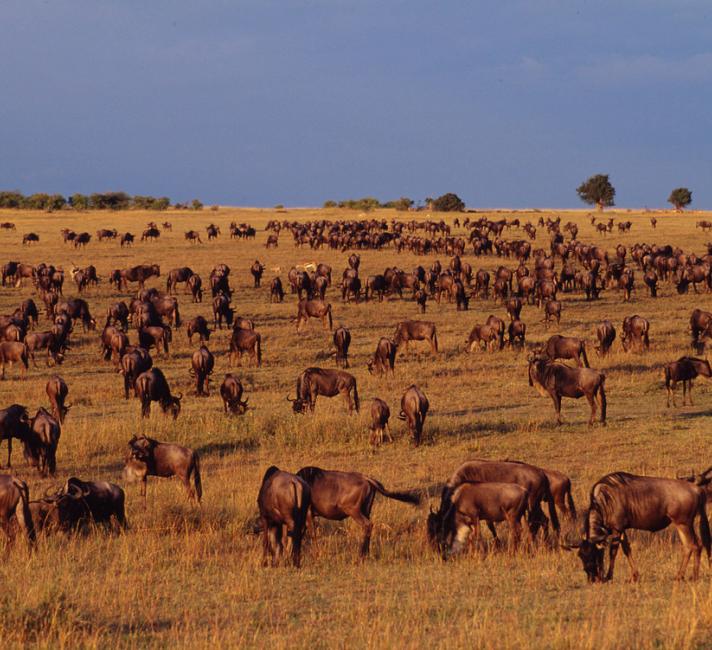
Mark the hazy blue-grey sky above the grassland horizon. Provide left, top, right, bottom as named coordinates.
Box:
left=0, top=0, right=712, bottom=208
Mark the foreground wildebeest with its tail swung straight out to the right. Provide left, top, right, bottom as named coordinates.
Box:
left=297, top=467, right=420, bottom=557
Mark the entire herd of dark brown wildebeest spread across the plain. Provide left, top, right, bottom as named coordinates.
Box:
left=0, top=215, right=712, bottom=582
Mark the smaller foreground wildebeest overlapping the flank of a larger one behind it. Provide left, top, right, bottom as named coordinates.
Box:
left=427, top=481, right=534, bottom=559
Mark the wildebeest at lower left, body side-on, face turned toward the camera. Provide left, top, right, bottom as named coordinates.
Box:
left=124, top=436, right=203, bottom=507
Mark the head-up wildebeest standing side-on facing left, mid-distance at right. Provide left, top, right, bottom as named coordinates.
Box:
left=529, top=355, right=606, bottom=426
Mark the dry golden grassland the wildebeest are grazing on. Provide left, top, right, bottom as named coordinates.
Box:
left=0, top=208, right=712, bottom=648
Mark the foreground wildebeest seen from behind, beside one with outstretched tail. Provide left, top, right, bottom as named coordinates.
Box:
left=257, top=465, right=311, bottom=568
